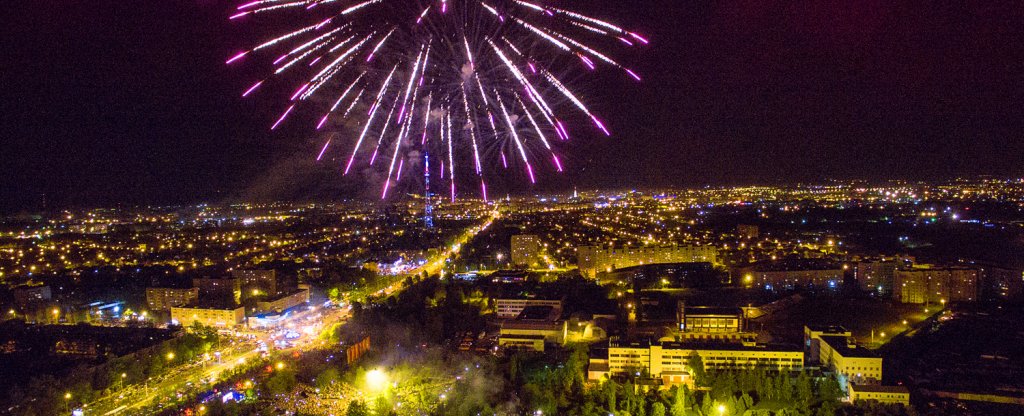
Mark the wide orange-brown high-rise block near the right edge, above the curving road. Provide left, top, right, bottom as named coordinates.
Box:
left=893, top=267, right=979, bottom=303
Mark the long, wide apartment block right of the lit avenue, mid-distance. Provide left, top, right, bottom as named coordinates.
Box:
left=577, top=246, right=718, bottom=278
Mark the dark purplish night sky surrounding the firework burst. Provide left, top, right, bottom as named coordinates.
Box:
left=0, top=0, right=1024, bottom=211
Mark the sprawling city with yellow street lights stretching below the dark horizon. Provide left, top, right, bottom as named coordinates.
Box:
left=0, top=179, right=1024, bottom=416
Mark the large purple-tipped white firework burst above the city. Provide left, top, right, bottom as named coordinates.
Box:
left=226, top=0, right=647, bottom=200
